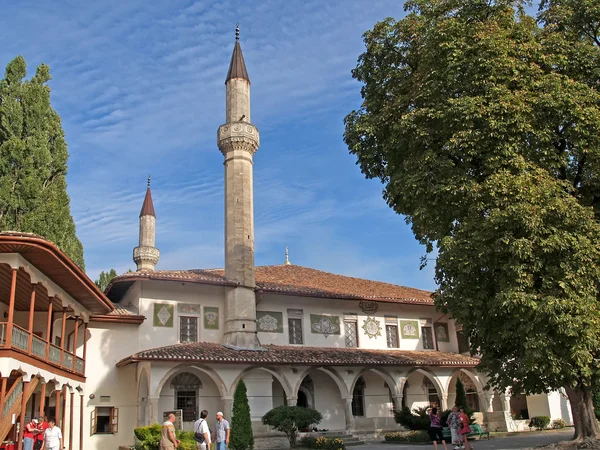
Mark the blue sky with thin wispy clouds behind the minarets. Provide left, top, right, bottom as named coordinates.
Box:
left=0, top=0, right=435, bottom=289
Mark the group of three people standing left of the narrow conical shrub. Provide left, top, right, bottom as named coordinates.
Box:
left=160, top=410, right=231, bottom=450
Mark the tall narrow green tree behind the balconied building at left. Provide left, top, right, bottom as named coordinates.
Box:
left=0, top=56, right=84, bottom=269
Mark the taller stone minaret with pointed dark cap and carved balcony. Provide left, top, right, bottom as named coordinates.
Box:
left=217, top=26, right=260, bottom=349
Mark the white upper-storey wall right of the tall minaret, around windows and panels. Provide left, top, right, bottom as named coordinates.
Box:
left=257, top=293, right=458, bottom=352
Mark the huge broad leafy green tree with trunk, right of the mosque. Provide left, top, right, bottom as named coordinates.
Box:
left=345, top=0, right=600, bottom=438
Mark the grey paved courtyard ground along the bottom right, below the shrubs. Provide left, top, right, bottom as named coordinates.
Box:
left=359, top=429, right=573, bottom=450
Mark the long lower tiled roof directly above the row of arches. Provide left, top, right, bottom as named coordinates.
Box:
left=117, top=342, right=479, bottom=367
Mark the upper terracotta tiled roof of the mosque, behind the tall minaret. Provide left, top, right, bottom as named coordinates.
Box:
left=108, top=264, right=433, bottom=305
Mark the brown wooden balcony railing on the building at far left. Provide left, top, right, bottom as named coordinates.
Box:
left=0, top=322, right=85, bottom=375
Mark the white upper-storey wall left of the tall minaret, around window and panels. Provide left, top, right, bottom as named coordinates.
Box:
left=138, top=280, right=225, bottom=351
